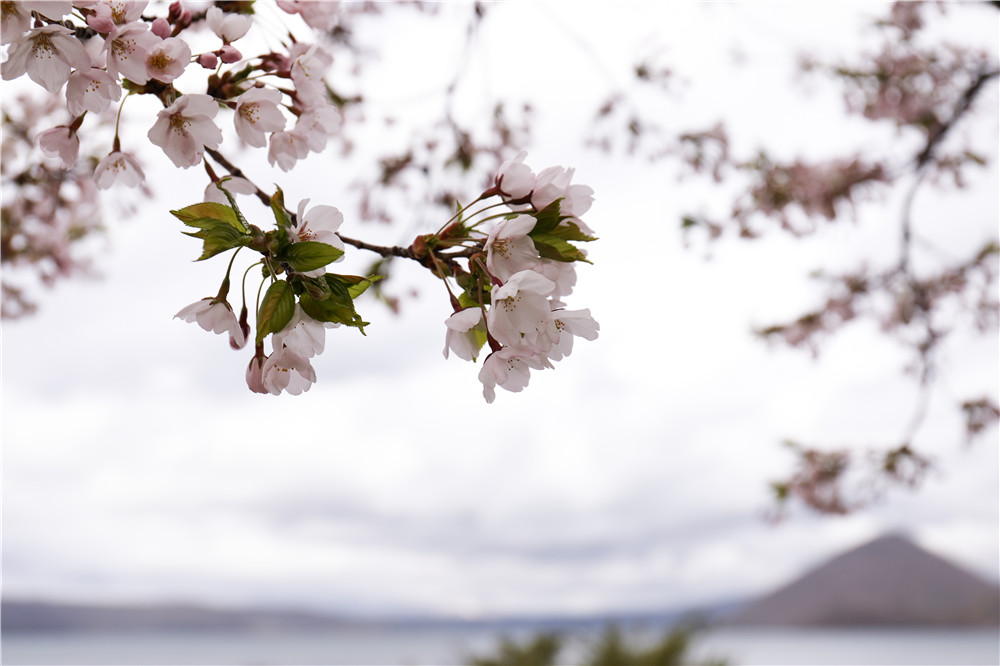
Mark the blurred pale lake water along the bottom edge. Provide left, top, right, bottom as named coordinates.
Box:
left=0, top=627, right=1000, bottom=666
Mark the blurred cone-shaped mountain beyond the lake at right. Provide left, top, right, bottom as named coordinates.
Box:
left=729, top=535, right=1000, bottom=627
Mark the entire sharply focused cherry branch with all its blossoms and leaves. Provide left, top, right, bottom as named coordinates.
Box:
left=2, top=0, right=598, bottom=402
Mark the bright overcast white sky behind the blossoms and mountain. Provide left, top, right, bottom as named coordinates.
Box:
left=2, top=3, right=1000, bottom=616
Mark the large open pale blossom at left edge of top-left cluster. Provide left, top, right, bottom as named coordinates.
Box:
left=3, top=25, right=90, bottom=92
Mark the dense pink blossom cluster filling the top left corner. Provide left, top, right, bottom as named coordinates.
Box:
left=2, top=0, right=340, bottom=189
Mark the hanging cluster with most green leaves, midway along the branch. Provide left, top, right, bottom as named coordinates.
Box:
left=172, top=183, right=360, bottom=395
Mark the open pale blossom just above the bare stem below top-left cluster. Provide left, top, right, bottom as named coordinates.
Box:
left=148, top=94, right=222, bottom=168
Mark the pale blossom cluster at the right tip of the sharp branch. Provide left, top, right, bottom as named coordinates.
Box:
left=436, top=151, right=600, bottom=402
